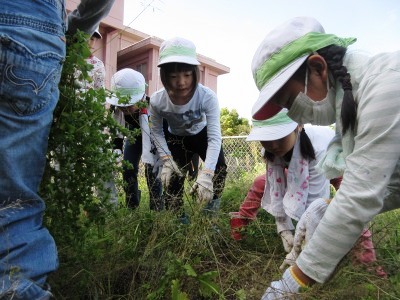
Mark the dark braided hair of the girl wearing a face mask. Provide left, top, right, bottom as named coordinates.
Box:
left=317, top=45, right=357, bottom=135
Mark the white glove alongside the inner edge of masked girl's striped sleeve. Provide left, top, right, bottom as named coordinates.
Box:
left=279, top=198, right=330, bottom=270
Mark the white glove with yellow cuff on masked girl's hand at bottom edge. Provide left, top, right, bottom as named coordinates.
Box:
left=261, top=267, right=306, bottom=300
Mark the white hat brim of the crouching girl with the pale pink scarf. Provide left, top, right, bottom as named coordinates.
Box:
left=246, top=122, right=297, bottom=142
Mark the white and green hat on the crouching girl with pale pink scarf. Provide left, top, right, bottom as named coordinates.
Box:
left=246, top=109, right=298, bottom=141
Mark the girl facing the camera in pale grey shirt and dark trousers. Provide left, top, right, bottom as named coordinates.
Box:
left=150, top=37, right=226, bottom=222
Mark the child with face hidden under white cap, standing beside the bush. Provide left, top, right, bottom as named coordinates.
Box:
left=107, top=68, right=163, bottom=210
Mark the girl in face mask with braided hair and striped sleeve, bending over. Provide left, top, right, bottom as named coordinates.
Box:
left=252, top=17, right=400, bottom=299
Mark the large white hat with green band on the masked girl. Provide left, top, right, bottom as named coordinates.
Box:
left=251, top=17, right=356, bottom=120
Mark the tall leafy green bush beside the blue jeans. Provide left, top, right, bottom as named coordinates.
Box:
left=40, top=32, right=135, bottom=246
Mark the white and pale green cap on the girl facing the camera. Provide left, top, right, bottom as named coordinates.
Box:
left=157, top=37, right=200, bottom=67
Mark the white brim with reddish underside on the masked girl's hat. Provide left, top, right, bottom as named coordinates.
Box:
left=251, top=54, right=309, bottom=120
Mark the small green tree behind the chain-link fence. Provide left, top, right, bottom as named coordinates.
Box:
left=220, top=108, right=250, bottom=136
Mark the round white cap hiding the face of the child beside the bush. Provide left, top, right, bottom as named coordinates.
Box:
left=106, top=68, right=146, bottom=107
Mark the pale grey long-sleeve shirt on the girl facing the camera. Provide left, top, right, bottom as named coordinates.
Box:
left=150, top=84, right=222, bottom=171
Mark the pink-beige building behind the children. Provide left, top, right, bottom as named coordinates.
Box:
left=66, top=0, right=230, bottom=95
